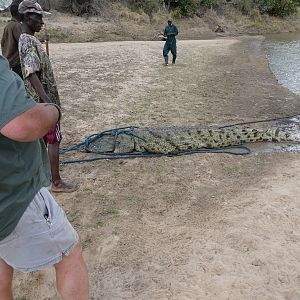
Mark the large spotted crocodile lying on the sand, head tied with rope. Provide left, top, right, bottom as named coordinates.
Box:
left=85, top=126, right=299, bottom=154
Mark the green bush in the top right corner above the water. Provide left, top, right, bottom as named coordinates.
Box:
left=254, top=0, right=298, bottom=17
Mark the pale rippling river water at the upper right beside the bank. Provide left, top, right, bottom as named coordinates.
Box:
left=264, top=33, right=300, bottom=95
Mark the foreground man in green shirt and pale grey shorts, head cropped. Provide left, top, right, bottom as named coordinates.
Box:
left=0, top=56, right=88, bottom=300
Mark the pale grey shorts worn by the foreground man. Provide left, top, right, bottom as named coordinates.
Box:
left=0, top=188, right=79, bottom=272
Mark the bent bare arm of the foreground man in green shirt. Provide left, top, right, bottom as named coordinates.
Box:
left=0, top=103, right=60, bottom=142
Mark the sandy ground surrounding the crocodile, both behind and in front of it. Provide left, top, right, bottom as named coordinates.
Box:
left=9, top=37, right=300, bottom=300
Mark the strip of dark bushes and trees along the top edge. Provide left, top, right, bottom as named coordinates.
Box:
left=39, top=0, right=300, bottom=18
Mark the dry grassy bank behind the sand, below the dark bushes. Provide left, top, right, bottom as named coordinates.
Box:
left=0, top=1, right=300, bottom=43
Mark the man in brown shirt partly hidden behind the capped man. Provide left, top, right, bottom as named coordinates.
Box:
left=1, top=0, right=22, bottom=77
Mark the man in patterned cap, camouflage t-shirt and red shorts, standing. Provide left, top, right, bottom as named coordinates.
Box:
left=19, top=0, right=78, bottom=192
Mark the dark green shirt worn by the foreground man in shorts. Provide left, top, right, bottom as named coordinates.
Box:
left=0, top=56, right=50, bottom=240
